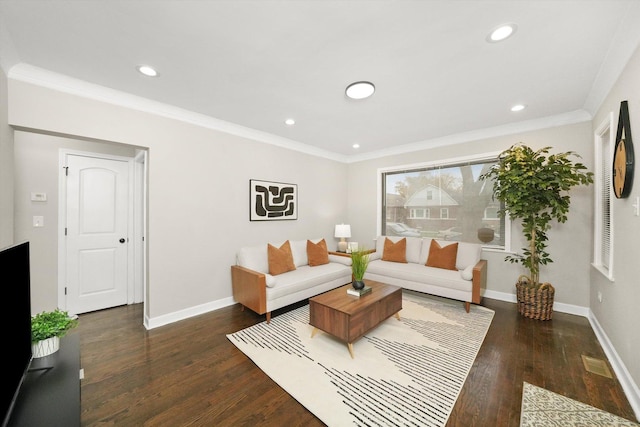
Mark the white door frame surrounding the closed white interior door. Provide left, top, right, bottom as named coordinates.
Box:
left=58, top=148, right=147, bottom=310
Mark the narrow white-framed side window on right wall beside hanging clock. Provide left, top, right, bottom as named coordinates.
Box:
left=591, top=112, right=615, bottom=282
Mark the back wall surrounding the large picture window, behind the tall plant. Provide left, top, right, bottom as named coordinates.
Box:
left=349, top=122, right=593, bottom=308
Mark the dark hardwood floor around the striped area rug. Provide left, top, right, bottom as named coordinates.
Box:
left=77, top=298, right=636, bottom=427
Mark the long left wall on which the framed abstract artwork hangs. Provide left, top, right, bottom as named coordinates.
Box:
left=9, top=79, right=347, bottom=325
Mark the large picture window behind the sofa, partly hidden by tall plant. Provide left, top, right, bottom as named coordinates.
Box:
left=380, top=155, right=506, bottom=248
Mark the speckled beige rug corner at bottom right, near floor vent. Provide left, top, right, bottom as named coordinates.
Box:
left=520, top=382, right=640, bottom=427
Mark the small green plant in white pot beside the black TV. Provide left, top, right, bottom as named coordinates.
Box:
left=31, top=308, right=78, bottom=358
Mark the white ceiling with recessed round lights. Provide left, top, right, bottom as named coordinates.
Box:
left=0, top=0, right=640, bottom=159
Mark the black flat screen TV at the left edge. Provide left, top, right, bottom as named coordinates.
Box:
left=0, top=242, right=32, bottom=427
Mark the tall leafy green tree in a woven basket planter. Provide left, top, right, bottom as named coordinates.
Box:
left=480, top=143, right=593, bottom=320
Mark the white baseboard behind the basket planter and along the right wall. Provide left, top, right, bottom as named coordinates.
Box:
left=483, top=290, right=640, bottom=420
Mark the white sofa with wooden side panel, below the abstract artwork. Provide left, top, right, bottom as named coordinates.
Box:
left=231, top=239, right=351, bottom=323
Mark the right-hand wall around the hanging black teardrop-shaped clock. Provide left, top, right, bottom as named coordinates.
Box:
left=590, top=42, right=640, bottom=413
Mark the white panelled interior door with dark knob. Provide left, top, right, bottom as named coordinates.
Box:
left=65, top=154, right=130, bottom=314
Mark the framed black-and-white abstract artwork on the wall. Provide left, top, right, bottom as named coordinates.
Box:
left=249, top=179, right=298, bottom=221
